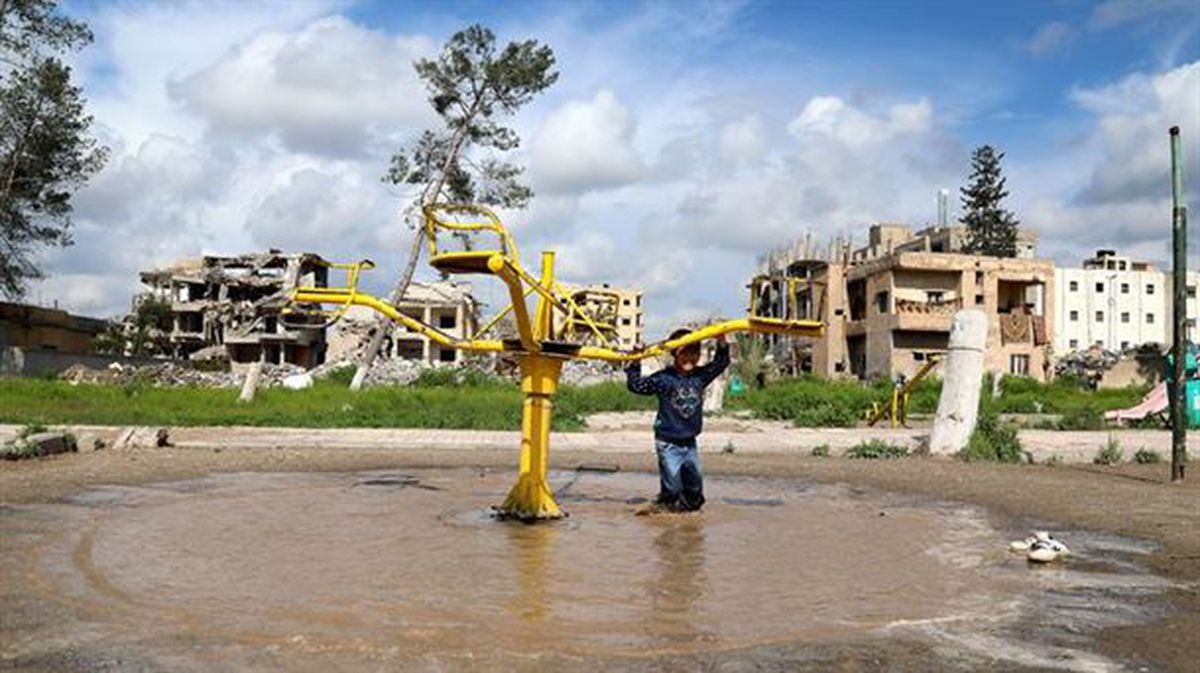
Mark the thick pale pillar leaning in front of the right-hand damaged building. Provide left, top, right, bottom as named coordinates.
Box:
left=929, top=310, right=988, bottom=456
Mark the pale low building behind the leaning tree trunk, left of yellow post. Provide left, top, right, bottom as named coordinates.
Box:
left=328, top=281, right=479, bottom=365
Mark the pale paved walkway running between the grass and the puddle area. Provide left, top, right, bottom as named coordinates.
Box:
left=0, top=423, right=1200, bottom=462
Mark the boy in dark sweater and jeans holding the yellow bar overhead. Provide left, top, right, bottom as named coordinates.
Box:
left=625, top=330, right=730, bottom=513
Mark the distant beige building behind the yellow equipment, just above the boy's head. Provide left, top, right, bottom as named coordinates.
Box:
left=554, top=283, right=644, bottom=349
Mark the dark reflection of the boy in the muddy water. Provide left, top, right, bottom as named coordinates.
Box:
left=647, top=516, right=708, bottom=643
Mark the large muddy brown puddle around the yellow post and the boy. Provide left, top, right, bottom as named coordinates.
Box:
left=0, top=469, right=1169, bottom=671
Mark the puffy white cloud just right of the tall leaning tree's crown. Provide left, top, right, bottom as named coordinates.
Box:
left=529, top=89, right=643, bottom=193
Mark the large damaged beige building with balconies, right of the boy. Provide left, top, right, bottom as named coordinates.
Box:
left=751, top=224, right=1055, bottom=380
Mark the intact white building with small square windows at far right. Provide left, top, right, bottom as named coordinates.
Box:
left=1055, top=250, right=1200, bottom=353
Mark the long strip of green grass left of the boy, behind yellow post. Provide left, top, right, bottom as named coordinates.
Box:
left=0, top=377, right=654, bottom=431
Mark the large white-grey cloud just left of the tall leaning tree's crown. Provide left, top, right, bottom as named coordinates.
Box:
left=172, top=17, right=433, bottom=157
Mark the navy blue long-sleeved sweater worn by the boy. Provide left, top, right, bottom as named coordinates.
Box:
left=625, top=344, right=730, bottom=446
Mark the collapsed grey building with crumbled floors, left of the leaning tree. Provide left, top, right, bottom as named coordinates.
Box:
left=140, top=250, right=329, bottom=369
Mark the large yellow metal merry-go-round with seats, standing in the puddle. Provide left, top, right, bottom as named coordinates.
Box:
left=283, top=204, right=823, bottom=521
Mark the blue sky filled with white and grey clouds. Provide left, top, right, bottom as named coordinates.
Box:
left=31, top=0, right=1200, bottom=336
